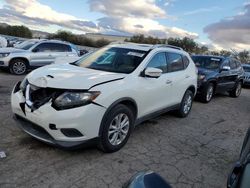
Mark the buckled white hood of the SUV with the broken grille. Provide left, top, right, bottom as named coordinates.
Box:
left=27, top=64, right=125, bottom=90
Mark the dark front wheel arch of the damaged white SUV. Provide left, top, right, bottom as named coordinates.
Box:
left=98, top=97, right=138, bottom=136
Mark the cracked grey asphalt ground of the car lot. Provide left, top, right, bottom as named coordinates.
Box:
left=0, top=71, right=250, bottom=188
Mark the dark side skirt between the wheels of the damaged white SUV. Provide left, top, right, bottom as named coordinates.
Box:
left=135, top=104, right=181, bottom=126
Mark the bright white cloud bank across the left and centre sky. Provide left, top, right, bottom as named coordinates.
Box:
left=0, top=0, right=198, bottom=38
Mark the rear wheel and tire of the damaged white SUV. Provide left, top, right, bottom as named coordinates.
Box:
left=177, top=90, right=194, bottom=118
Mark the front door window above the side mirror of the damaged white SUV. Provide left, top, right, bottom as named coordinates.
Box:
left=147, top=52, right=168, bottom=73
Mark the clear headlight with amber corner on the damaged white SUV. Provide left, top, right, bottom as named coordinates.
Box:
left=54, top=91, right=101, bottom=110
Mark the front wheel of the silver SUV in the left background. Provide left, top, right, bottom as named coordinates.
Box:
left=9, top=59, right=28, bottom=75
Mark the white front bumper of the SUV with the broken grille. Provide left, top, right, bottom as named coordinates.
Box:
left=11, top=83, right=106, bottom=147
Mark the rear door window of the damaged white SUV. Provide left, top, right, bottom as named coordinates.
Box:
left=167, top=52, right=184, bottom=72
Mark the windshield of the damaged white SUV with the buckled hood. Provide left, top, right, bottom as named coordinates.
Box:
left=76, top=46, right=146, bottom=74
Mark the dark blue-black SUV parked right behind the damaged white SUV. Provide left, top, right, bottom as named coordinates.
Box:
left=192, top=55, right=244, bottom=103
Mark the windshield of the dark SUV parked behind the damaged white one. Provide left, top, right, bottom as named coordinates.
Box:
left=192, top=56, right=222, bottom=70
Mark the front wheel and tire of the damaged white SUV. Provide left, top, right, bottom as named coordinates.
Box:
left=99, top=104, right=134, bottom=153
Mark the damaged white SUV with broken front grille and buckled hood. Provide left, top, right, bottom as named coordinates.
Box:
left=11, top=43, right=197, bottom=152
